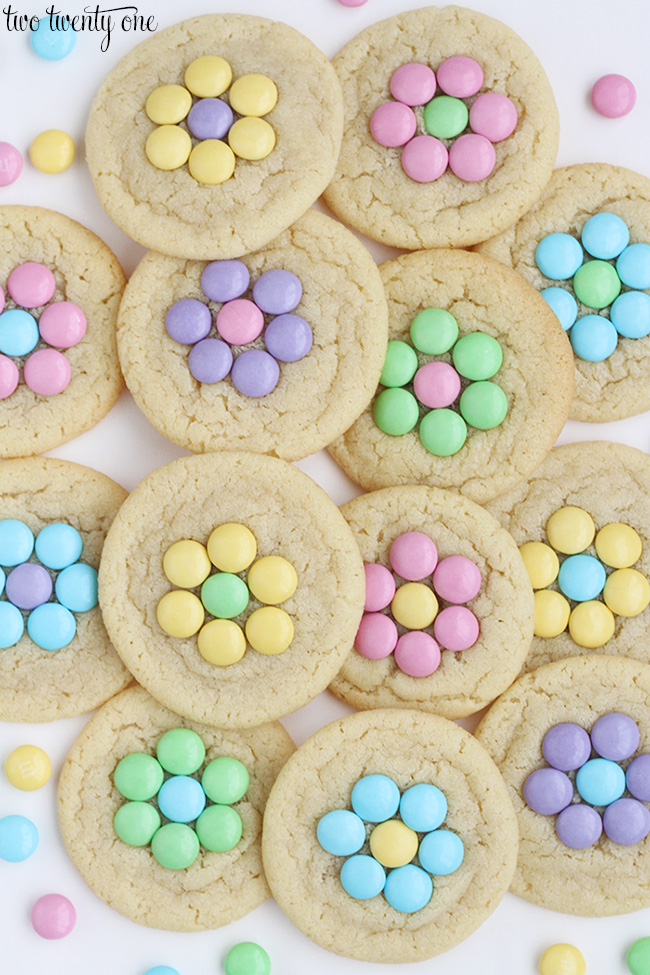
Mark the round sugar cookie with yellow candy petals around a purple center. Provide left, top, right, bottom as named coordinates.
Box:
left=86, top=14, right=343, bottom=260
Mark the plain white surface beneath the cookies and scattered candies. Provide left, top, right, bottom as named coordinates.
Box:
left=0, top=0, right=650, bottom=975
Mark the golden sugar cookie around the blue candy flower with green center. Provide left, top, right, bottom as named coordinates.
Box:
left=477, top=163, right=650, bottom=423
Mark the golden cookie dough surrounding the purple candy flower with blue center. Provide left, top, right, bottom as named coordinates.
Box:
left=476, top=655, right=650, bottom=917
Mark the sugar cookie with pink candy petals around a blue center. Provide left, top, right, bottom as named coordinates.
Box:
left=0, top=206, right=126, bottom=457
